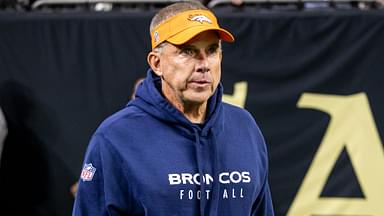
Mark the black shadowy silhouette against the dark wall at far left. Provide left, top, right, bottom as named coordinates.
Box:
left=0, top=81, right=50, bottom=216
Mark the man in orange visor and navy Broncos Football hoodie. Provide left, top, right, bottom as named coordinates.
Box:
left=73, top=1, right=273, bottom=216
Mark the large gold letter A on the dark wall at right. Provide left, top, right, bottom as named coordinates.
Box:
left=287, top=93, right=384, bottom=216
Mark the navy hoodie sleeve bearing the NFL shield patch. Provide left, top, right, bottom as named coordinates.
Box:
left=72, top=135, right=133, bottom=216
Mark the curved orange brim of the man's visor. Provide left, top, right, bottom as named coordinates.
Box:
left=167, top=26, right=235, bottom=45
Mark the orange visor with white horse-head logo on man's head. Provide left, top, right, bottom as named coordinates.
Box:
left=151, top=10, right=235, bottom=49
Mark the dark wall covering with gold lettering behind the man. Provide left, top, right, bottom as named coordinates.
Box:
left=0, top=11, right=384, bottom=216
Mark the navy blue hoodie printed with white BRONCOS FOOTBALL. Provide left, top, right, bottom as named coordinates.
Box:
left=73, top=70, right=273, bottom=216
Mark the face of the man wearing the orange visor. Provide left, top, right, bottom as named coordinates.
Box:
left=159, top=31, right=222, bottom=106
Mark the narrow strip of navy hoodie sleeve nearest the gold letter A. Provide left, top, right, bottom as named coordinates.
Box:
left=251, top=177, right=274, bottom=216
